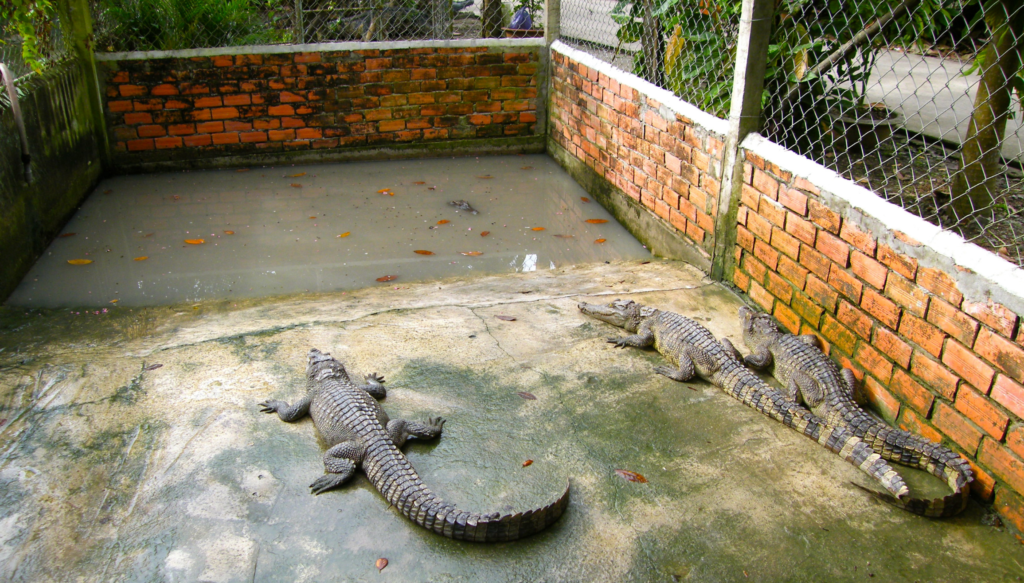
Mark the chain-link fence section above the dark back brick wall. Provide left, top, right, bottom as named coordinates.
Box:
left=86, top=0, right=493, bottom=51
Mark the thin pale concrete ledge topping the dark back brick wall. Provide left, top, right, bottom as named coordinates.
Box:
left=96, top=38, right=545, bottom=60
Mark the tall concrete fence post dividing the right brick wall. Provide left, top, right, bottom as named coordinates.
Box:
left=711, top=0, right=775, bottom=281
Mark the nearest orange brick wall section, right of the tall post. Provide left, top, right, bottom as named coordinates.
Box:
left=732, top=135, right=1024, bottom=530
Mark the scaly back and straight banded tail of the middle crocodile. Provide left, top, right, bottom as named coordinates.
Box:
left=647, top=310, right=907, bottom=497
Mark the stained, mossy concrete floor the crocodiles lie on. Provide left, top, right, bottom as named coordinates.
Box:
left=0, top=261, right=1024, bottom=582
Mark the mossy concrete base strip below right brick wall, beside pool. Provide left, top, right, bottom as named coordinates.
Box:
left=548, top=138, right=711, bottom=273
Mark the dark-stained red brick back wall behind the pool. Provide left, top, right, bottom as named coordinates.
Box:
left=101, top=41, right=544, bottom=165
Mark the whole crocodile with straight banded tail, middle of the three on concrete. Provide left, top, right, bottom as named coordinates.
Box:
left=579, top=299, right=907, bottom=498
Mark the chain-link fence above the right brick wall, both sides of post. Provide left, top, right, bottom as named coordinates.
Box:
left=561, top=0, right=1024, bottom=264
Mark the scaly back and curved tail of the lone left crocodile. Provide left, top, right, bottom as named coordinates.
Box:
left=310, top=378, right=569, bottom=542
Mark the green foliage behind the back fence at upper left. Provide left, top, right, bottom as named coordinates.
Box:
left=98, top=0, right=289, bottom=50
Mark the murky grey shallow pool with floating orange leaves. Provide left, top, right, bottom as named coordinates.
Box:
left=7, top=155, right=650, bottom=307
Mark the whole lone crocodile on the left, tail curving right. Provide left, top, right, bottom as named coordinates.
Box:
left=260, top=348, right=569, bottom=542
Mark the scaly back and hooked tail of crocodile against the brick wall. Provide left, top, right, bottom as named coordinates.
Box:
left=768, top=332, right=974, bottom=517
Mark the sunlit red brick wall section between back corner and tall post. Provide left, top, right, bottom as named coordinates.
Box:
left=549, top=51, right=725, bottom=257
